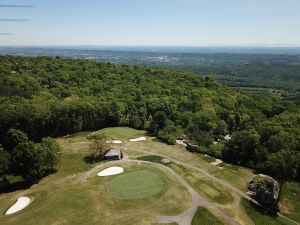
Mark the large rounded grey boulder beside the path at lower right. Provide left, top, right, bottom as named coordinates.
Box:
left=248, top=174, right=279, bottom=207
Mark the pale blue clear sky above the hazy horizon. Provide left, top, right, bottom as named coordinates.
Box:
left=0, top=0, right=300, bottom=46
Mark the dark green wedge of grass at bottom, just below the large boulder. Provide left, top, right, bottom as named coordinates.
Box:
left=241, top=199, right=294, bottom=225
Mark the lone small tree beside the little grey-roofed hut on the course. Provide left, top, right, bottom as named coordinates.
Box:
left=87, top=133, right=110, bottom=160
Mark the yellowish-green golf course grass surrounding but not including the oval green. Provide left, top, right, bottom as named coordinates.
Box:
left=0, top=128, right=299, bottom=225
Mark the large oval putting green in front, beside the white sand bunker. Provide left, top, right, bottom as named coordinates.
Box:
left=109, top=169, right=165, bottom=200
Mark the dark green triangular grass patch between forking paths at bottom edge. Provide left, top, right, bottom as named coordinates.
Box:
left=192, top=207, right=224, bottom=225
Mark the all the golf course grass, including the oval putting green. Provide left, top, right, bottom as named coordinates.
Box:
left=0, top=128, right=298, bottom=225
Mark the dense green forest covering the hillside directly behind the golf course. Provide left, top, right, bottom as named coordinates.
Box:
left=0, top=56, right=300, bottom=185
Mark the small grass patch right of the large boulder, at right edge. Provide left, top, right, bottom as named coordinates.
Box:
left=278, top=182, right=300, bottom=222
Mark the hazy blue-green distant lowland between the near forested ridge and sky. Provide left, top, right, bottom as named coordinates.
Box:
left=0, top=47, right=300, bottom=94
